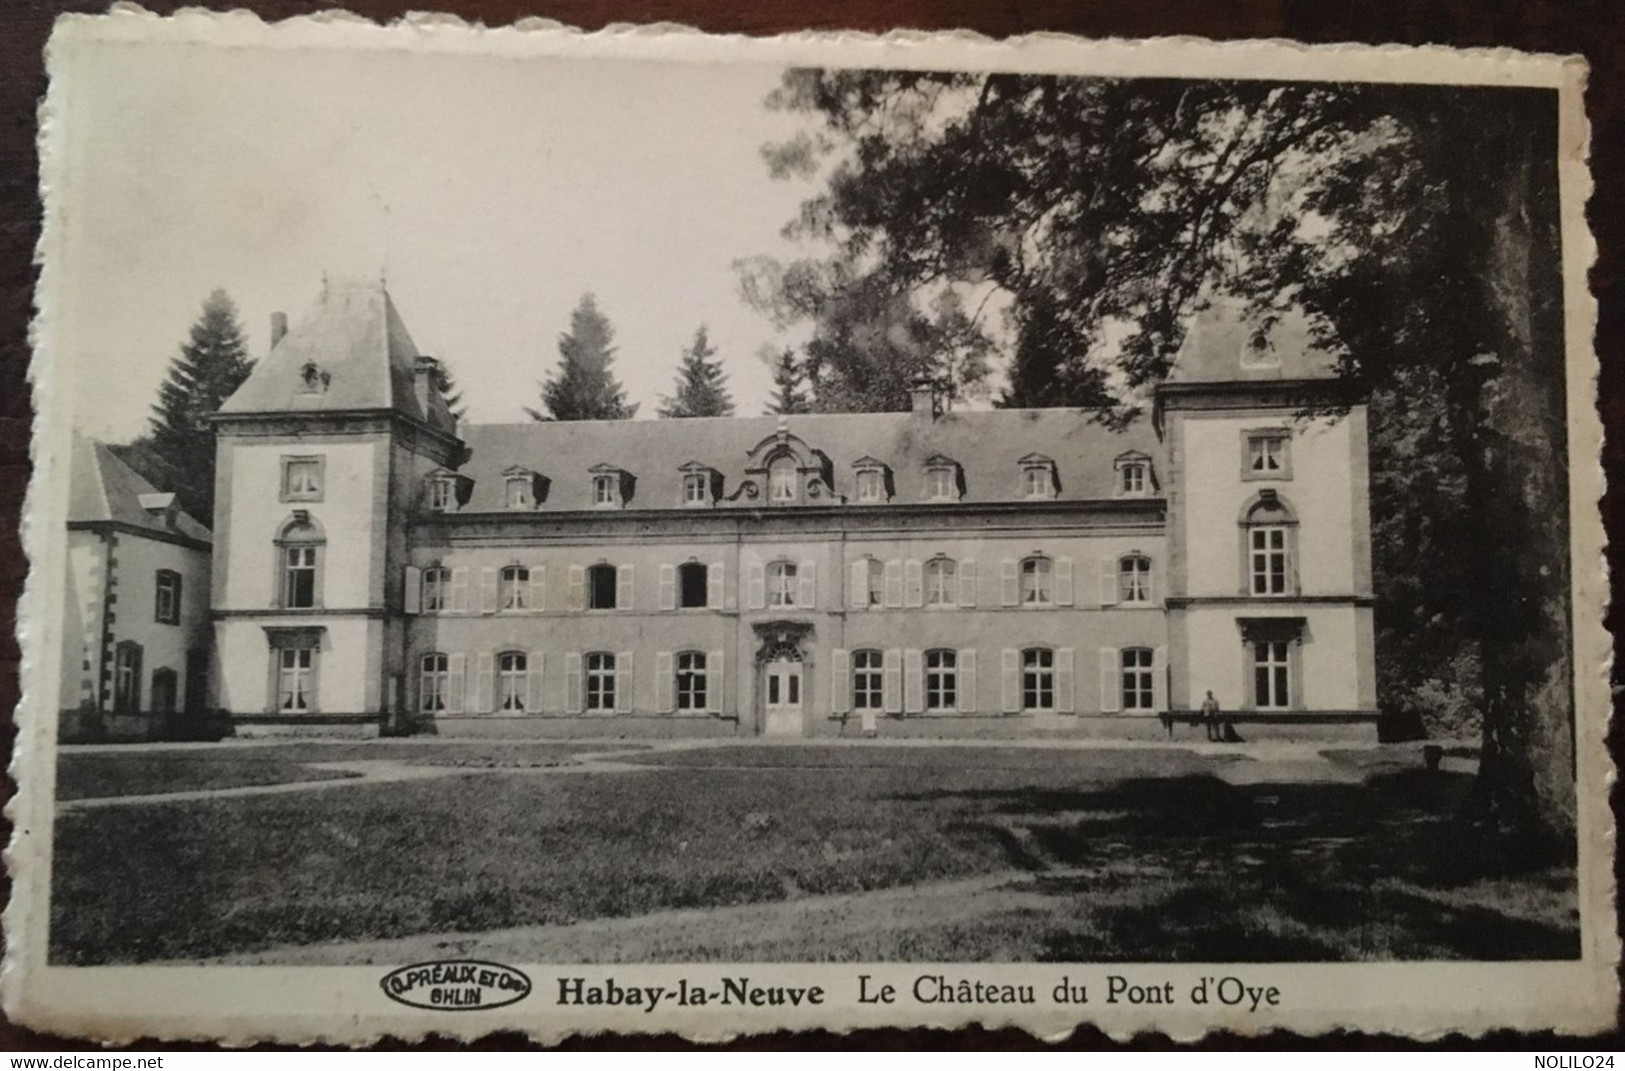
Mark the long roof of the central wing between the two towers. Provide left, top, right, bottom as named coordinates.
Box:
left=445, top=410, right=1160, bottom=514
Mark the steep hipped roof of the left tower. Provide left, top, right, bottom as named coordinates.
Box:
left=219, top=280, right=457, bottom=432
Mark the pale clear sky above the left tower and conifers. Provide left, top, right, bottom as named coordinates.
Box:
left=54, top=44, right=814, bottom=440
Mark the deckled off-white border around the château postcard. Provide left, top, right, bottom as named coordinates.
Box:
left=9, top=3, right=1619, bottom=1045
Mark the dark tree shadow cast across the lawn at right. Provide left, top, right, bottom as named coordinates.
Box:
left=907, top=770, right=1580, bottom=962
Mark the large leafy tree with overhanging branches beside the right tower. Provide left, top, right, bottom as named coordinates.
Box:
left=757, top=70, right=1575, bottom=858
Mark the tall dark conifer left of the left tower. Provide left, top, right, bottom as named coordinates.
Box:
left=147, top=289, right=254, bottom=523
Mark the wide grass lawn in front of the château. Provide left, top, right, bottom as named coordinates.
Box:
left=50, top=748, right=1578, bottom=964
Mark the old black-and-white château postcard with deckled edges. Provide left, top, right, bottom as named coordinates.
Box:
left=8, top=13, right=1619, bottom=1040
